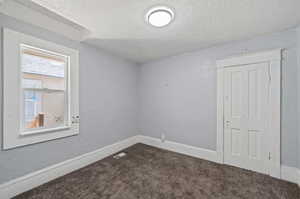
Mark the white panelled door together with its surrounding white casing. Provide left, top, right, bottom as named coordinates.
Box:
left=217, top=49, right=281, bottom=178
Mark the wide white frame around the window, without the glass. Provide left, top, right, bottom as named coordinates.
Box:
left=3, top=28, right=79, bottom=150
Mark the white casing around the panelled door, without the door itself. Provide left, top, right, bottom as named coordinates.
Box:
left=217, top=49, right=282, bottom=178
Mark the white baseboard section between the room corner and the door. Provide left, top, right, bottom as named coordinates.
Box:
left=138, top=135, right=220, bottom=163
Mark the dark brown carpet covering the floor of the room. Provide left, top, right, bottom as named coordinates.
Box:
left=15, top=144, right=300, bottom=199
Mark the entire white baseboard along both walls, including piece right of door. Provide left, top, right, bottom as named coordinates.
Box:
left=0, top=135, right=300, bottom=199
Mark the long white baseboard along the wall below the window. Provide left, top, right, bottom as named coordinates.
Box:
left=0, top=136, right=138, bottom=199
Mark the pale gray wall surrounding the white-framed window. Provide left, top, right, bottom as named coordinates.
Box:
left=0, top=15, right=137, bottom=184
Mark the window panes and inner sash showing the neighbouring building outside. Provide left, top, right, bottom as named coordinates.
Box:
left=21, top=45, right=68, bottom=131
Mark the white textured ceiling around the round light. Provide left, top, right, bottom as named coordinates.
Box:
left=32, top=0, right=300, bottom=63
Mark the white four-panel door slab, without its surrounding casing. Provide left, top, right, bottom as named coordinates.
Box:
left=224, top=62, right=270, bottom=174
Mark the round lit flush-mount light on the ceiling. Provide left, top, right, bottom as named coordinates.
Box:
left=146, top=6, right=175, bottom=28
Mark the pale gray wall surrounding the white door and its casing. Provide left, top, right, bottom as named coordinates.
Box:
left=139, top=30, right=298, bottom=166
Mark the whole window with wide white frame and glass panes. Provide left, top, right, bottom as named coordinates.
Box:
left=3, top=29, right=79, bottom=149
